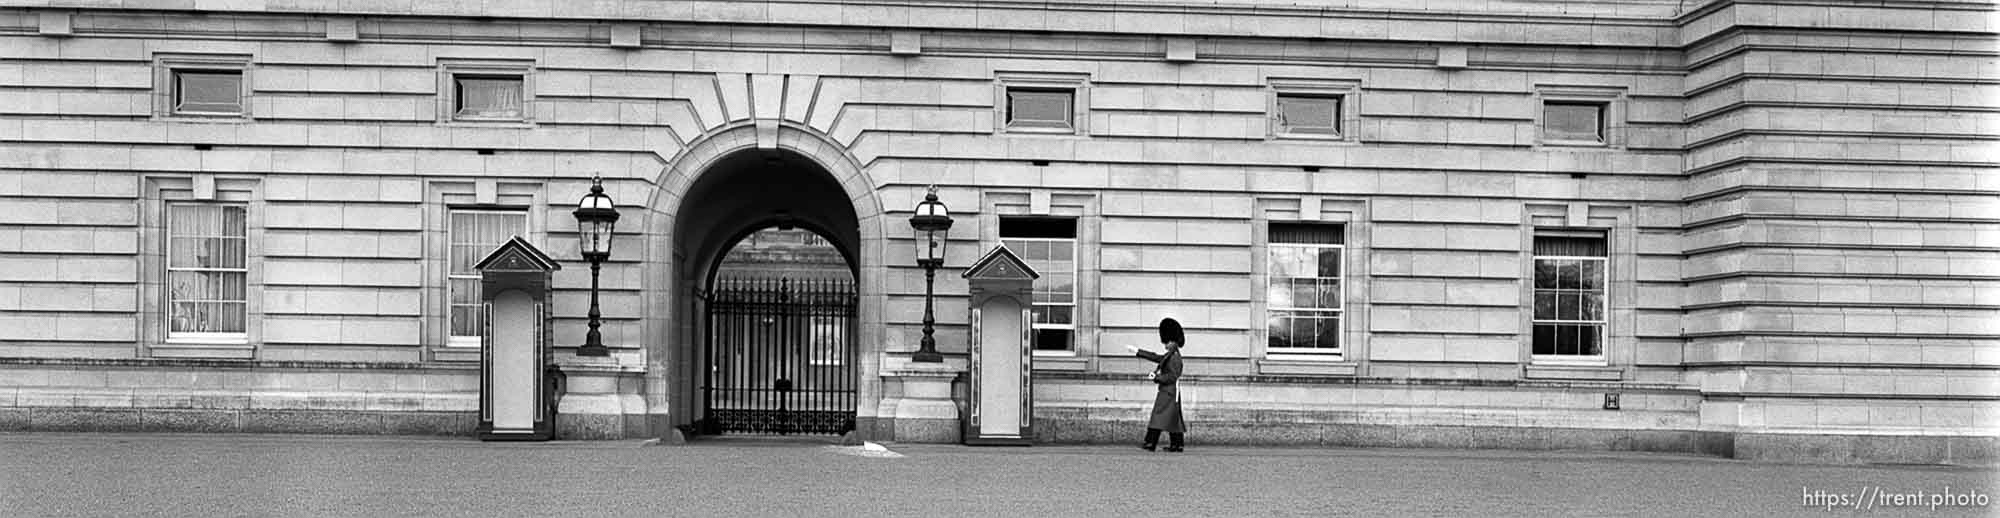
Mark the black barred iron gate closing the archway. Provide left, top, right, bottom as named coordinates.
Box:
left=702, top=278, right=856, bottom=434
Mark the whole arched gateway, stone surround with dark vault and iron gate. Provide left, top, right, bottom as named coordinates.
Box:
left=646, top=122, right=886, bottom=440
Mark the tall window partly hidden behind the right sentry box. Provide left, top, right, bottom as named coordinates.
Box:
left=1000, top=218, right=1076, bottom=350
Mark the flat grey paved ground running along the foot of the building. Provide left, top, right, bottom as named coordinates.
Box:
left=0, top=434, right=2000, bottom=516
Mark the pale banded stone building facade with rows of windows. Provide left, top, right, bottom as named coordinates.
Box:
left=0, top=0, right=2000, bottom=462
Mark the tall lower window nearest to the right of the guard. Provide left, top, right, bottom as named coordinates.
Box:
left=1264, top=222, right=1346, bottom=354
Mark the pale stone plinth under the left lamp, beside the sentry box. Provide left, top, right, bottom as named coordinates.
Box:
left=556, top=356, right=650, bottom=440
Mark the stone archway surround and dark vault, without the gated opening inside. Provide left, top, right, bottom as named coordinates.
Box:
left=644, top=122, right=886, bottom=440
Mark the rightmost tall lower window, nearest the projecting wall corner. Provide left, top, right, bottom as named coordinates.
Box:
left=1534, top=236, right=1608, bottom=362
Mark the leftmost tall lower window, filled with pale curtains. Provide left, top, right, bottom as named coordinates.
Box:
left=166, top=204, right=250, bottom=342
